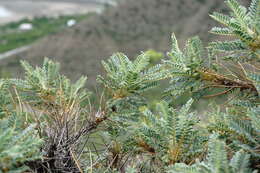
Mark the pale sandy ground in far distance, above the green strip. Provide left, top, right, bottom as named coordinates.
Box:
left=0, top=0, right=102, bottom=24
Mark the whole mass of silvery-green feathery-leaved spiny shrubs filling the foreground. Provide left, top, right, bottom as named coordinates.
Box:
left=0, top=0, right=260, bottom=173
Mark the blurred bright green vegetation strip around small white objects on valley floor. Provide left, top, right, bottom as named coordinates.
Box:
left=0, top=14, right=89, bottom=53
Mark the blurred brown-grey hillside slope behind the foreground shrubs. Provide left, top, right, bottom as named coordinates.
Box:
left=0, top=0, right=249, bottom=86
